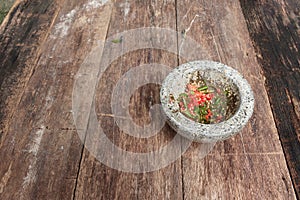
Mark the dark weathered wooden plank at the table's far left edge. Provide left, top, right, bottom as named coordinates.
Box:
left=0, top=1, right=59, bottom=150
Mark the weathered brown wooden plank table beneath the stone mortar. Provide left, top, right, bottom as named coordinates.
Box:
left=0, top=0, right=300, bottom=200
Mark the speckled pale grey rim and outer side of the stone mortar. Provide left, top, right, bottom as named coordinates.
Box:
left=160, top=60, right=254, bottom=142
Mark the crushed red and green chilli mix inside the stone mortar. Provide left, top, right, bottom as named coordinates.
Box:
left=170, top=72, right=239, bottom=124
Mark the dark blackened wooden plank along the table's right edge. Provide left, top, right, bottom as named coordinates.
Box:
left=241, top=0, right=300, bottom=198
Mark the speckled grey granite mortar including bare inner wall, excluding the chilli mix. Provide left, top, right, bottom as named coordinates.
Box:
left=160, top=60, right=254, bottom=143
